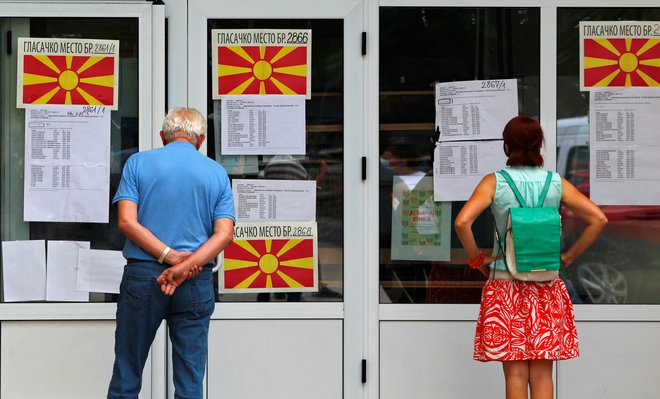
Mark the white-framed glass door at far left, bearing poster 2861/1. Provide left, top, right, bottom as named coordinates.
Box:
left=0, top=1, right=165, bottom=398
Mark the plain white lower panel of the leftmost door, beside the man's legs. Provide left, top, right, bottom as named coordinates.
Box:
left=0, top=320, right=152, bottom=399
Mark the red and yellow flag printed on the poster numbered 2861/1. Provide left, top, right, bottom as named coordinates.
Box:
left=22, top=54, right=116, bottom=108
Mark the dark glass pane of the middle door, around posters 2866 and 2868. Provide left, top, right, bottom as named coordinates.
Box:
left=207, top=19, right=344, bottom=302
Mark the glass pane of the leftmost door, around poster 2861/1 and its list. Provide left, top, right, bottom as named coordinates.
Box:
left=0, top=18, right=139, bottom=302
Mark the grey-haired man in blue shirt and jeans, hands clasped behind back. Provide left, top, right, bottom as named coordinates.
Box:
left=108, top=108, right=236, bottom=399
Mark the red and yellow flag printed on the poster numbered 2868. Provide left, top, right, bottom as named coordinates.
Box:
left=220, top=238, right=317, bottom=292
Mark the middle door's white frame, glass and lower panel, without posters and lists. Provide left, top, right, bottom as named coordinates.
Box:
left=186, top=0, right=367, bottom=398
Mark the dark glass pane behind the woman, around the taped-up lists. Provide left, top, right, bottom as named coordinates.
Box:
left=379, top=7, right=540, bottom=303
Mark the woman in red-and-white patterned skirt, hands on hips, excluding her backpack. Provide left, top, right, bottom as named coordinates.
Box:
left=454, top=116, right=607, bottom=399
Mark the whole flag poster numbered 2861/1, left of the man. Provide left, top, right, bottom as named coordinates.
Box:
left=16, top=37, right=119, bottom=110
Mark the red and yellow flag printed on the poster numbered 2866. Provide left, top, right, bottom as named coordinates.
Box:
left=216, top=45, right=310, bottom=97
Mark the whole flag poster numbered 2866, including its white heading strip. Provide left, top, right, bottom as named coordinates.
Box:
left=211, top=29, right=312, bottom=100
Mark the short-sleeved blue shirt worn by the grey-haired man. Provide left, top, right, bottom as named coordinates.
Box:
left=112, top=141, right=236, bottom=260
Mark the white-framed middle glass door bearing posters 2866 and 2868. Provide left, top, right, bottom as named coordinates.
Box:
left=183, top=0, right=366, bottom=398
